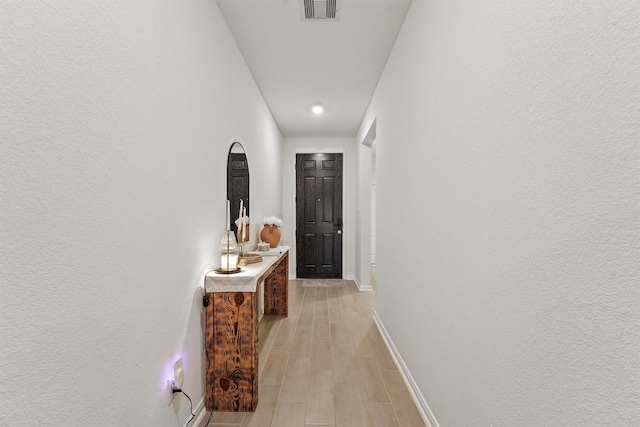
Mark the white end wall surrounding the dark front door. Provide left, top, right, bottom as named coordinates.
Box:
left=280, top=138, right=358, bottom=279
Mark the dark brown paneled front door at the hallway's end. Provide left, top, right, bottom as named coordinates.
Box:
left=296, top=153, right=342, bottom=278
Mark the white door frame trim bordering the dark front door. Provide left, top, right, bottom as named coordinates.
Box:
left=290, top=147, right=350, bottom=279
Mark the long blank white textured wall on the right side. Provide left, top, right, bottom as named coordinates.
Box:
left=358, top=0, right=640, bottom=426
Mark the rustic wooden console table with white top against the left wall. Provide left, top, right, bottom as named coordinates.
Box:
left=204, top=246, right=289, bottom=412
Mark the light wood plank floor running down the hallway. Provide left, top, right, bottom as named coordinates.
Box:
left=200, top=280, right=425, bottom=427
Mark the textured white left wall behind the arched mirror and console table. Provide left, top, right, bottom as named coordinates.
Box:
left=0, top=0, right=282, bottom=426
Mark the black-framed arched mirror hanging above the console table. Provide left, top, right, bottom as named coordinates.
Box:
left=227, top=142, right=249, bottom=237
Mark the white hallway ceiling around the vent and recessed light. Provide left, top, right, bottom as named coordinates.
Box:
left=217, top=0, right=411, bottom=138
